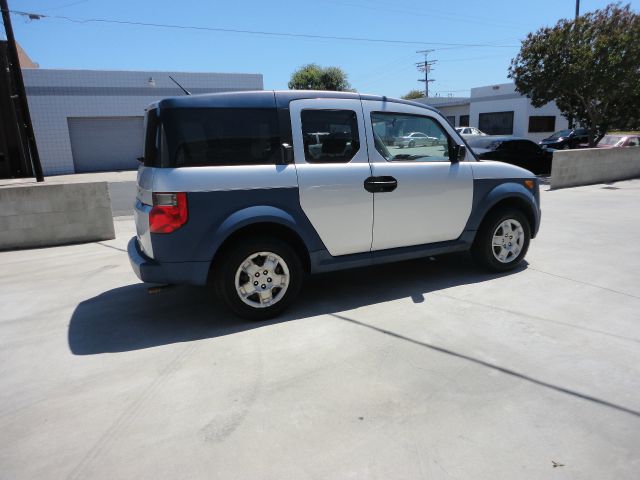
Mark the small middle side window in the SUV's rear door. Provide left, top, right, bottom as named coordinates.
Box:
left=301, top=110, right=360, bottom=163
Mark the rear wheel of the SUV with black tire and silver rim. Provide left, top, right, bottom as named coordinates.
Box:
left=213, top=238, right=303, bottom=320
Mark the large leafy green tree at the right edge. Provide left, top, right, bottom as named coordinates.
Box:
left=509, top=3, right=640, bottom=145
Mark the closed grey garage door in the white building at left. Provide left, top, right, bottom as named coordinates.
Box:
left=67, top=117, right=143, bottom=173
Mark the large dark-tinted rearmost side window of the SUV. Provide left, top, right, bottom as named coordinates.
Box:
left=162, top=108, right=280, bottom=167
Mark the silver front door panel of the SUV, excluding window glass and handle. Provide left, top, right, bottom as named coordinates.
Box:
left=362, top=101, right=476, bottom=250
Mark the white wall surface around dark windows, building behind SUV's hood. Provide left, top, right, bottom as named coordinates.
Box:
left=469, top=83, right=568, bottom=142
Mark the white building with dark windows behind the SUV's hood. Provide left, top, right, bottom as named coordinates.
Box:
left=417, top=83, right=568, bottom=142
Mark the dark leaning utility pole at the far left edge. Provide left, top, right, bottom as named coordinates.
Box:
left=0, top=0, right=44, bottom=182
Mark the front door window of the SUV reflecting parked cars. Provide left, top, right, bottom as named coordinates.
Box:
left=371, top=112, right=449, bottom=162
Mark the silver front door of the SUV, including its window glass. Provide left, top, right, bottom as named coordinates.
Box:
left=362, top=100, right=473, bottom=250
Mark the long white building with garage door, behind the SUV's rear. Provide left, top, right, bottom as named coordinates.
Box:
left=22, top=68, right=263, bottom=175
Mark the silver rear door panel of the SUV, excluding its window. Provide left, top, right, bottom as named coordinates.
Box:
left=289, top=99, right=373, bottom=256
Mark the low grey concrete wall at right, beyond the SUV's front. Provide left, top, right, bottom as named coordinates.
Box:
left=551, top=147, right=640, bottom=188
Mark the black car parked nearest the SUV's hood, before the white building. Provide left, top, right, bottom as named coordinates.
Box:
left=467, top=136, right=553, bottom=175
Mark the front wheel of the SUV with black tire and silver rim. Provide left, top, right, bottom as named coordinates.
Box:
left=471, top=208, right=531, bottom=272
